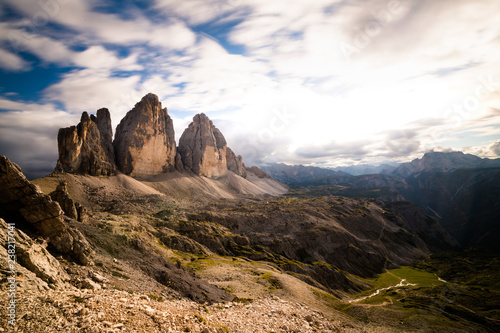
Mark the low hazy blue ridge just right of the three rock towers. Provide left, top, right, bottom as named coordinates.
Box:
left=261, top=163, right=351, bottom=185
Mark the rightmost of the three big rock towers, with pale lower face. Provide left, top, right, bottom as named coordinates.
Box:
left=178, top=113, right=228, bottom=177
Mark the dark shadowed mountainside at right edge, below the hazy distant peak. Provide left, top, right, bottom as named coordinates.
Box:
left=405, top=168, right=500, bottom=251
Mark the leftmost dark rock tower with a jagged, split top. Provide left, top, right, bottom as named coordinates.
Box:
left=56, top=109, right=116, bottom=176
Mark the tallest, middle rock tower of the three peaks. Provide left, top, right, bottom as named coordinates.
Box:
left=113, top=93, right=176, bottom=177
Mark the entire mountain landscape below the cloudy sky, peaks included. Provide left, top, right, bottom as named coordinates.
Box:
left=0, top=93, right=500, bottom=333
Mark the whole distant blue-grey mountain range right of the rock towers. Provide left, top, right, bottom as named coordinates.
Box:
left=263, top=152, right=500, bottom=251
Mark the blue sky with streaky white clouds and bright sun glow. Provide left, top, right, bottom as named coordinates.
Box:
left=0, top=0, right=500, bottom=178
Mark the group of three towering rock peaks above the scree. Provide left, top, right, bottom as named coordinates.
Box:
left=56, top=93, right=268, bottom=183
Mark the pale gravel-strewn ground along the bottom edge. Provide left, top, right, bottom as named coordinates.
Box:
left=0, top=289, right=365, bottom=333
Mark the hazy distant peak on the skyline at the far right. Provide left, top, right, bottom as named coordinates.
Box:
left=392, top=151, right=500, bottom=178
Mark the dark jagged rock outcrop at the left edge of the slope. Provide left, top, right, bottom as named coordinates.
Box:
left=0, top=156, right=91, bottom=265
